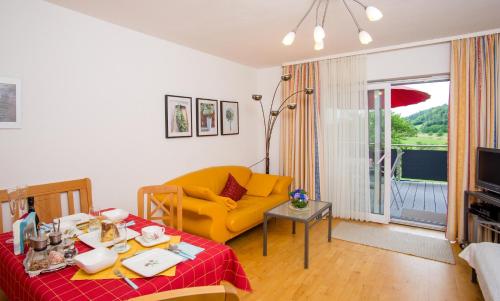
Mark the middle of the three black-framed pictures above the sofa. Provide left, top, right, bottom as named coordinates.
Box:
left=196, top=98, right=219, bottom=136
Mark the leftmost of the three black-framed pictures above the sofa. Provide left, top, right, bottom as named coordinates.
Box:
left=165, top=95, right=193, bottom=138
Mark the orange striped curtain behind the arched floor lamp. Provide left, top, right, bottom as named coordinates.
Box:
left=280, top=62, right=321, bottom=199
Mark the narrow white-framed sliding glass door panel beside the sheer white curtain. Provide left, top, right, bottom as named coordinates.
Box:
left=368, top=84, right=391, bottom=223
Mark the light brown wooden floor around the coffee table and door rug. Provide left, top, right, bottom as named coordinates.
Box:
left=228, top=220, right=483, bottom=301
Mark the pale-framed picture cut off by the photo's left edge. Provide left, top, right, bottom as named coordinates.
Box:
left=0, top=77, right=21, bottom=129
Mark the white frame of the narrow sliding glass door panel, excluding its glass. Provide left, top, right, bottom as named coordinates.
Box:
left=366, top=83, right=392, bottom=224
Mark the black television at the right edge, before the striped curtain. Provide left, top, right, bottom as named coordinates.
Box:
left=476, top=147, right=500, bottom=193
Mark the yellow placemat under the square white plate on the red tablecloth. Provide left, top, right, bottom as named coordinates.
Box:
left=71, top=236, right=181, bottom=280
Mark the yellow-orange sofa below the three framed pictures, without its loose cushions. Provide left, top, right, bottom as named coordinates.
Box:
left=164, top=166, right=292, bottom=242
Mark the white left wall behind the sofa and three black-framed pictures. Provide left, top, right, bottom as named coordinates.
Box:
left=0, top=0, right=264, bottom=216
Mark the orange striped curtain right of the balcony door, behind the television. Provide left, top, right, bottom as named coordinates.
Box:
left=446, top=34, right=500, bottom=241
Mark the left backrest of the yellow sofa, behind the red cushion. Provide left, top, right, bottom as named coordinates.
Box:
left=164, top=166, right=252, bottom=194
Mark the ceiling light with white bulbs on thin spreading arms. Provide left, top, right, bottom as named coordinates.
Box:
left=282, top=0, right=384, bottom=50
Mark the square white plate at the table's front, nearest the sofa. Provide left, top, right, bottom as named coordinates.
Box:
left=122, top=248, right=186, bottom=277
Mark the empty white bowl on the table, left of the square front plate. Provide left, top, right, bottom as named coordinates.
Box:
left=73, top=247, right=118, bottom=274
